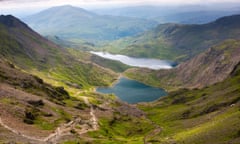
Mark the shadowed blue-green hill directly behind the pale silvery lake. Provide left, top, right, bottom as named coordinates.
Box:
left=103, top=15, right=240, bottom=61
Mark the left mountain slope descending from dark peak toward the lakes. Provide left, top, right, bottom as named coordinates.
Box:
left=0, top=16, right=117, bottom=88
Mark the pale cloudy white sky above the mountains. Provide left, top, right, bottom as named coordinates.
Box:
left=0, top=0, right=240, bottom=16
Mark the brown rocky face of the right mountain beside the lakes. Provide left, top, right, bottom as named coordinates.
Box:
left=173, top=40, right=240, bottom=88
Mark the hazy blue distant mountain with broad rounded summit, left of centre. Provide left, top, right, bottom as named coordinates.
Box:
left=24, top=5, right=157, bottom=42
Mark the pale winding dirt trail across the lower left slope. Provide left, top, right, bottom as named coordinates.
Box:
left=0, top=97, right=98, bottom=143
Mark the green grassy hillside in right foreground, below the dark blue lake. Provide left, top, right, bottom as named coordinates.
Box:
left=138, top=61, right=240, bottom=144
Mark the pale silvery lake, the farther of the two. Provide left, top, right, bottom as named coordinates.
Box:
left=91, top=51, right=177, bottom=70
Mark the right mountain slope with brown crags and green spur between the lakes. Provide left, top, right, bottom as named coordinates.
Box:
left=126, top=40, right=240, bottom=89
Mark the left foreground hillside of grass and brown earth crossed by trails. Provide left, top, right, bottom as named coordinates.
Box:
left=0, top=58, right=153, bottom=144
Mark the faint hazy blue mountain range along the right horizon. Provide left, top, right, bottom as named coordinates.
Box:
left=95, top=4, right=240, bottom=24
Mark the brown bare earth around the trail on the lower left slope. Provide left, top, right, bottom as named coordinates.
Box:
left=0, top=84, right=98, bottom=143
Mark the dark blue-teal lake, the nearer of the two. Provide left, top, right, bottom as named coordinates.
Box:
left=97, top=77, right=167, bottom=104
